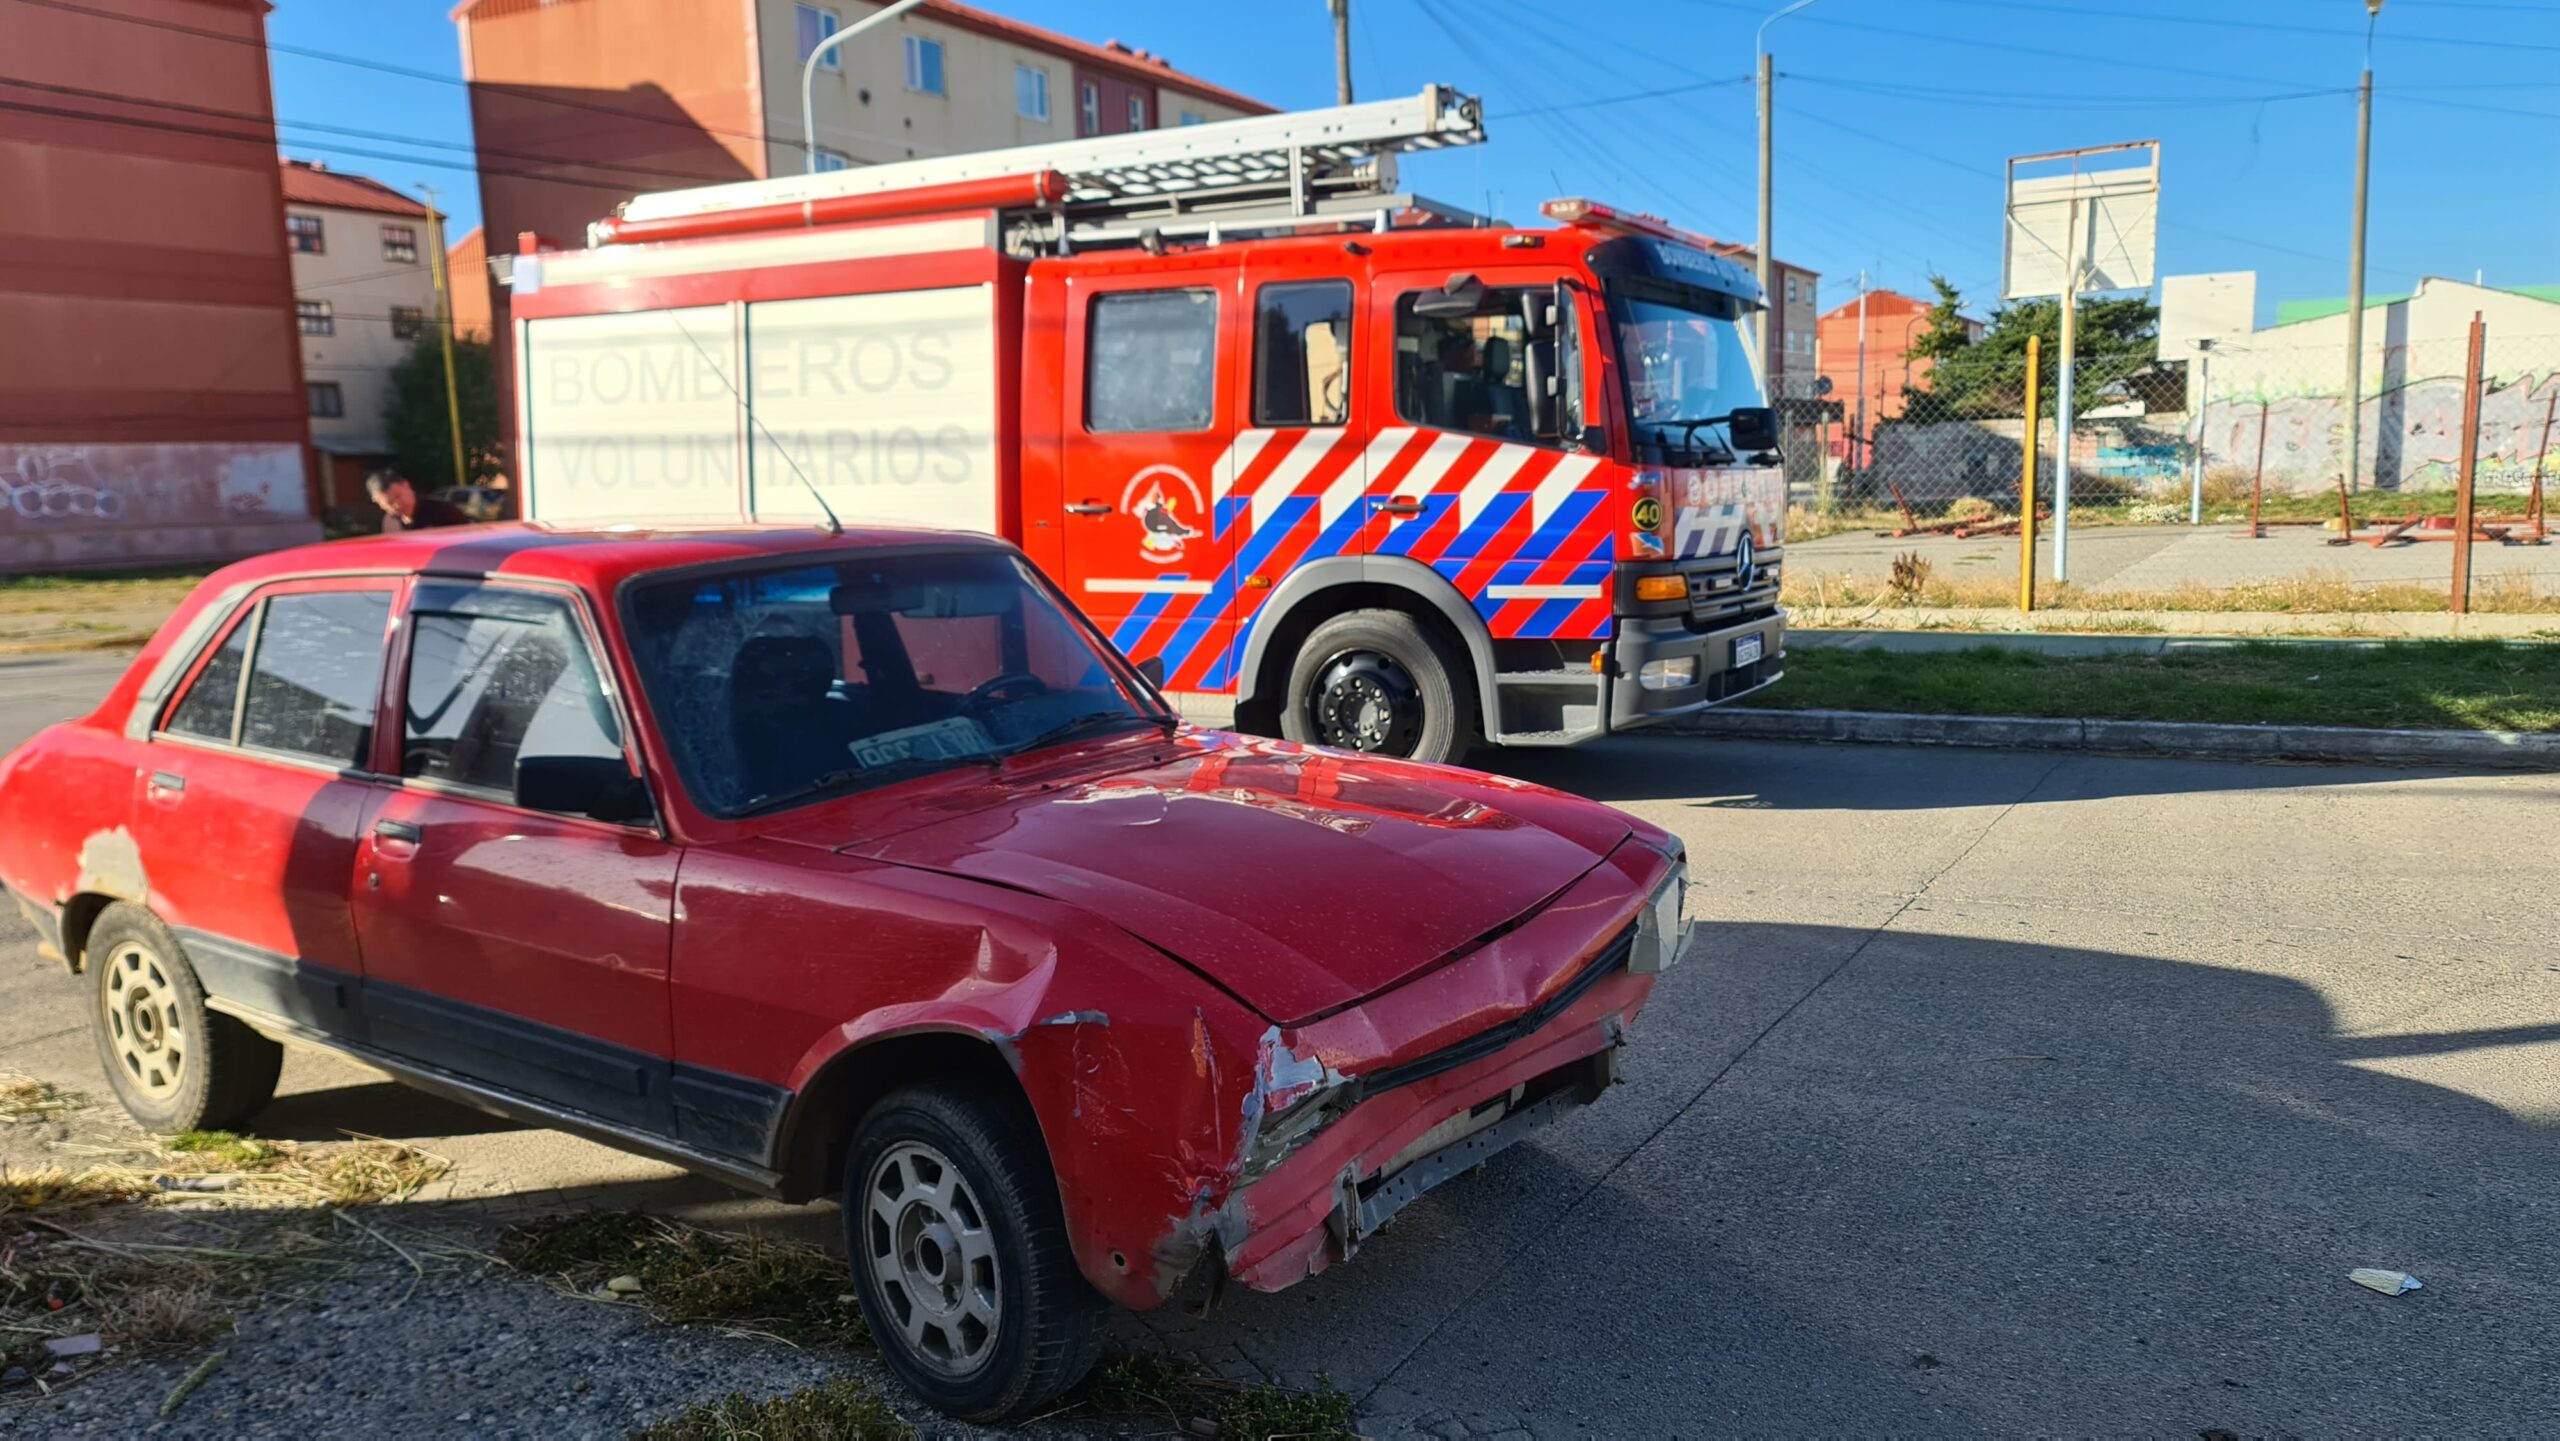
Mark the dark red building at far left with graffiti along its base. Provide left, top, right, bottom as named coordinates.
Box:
left=0, top=0, right=320, bottom=571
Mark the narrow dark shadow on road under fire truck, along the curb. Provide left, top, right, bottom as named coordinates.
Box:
left=1469, top=735, right=2450, bottom=811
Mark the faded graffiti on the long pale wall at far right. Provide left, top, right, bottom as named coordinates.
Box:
left=2204, top=371, right=2560, bottom=491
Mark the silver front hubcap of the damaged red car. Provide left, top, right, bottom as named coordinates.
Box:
left=863, top=1142, right=1004, bottom=1377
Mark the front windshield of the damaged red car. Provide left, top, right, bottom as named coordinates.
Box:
left=625, top=550, right=1162, bottom=816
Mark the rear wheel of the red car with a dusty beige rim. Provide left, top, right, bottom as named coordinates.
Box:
left=82, top=904, right=284, bottom=1134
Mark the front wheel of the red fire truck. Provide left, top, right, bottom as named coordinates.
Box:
left=1280, top=609, right=1475, bottom=763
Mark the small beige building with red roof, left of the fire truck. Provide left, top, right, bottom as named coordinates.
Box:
left=284, top=161, right=435, bottom=507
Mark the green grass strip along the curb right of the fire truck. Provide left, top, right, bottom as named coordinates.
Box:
left=1741, top=640, right=2560, bottom=732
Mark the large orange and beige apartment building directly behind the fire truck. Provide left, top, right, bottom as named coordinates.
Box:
left=453, top=0, right=1272, bottom=463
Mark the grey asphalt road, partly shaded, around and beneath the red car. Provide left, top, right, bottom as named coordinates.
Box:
left=0, top=658, right=2560, bottom=1436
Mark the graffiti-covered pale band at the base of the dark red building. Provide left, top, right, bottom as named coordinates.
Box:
left=0, top=443, right=305, bottom=532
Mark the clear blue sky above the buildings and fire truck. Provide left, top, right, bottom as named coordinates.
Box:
left=269, top=0, right=2560, bottom=323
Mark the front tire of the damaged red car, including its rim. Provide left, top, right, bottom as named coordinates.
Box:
left=842, top=1085, right=1103, bottom=1426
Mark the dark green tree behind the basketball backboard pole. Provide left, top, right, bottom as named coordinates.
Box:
left=1905, top=276, right=2161, bottom=420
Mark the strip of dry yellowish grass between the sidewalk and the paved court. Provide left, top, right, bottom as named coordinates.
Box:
left=1784, top=563, right=2560, bottom=614
